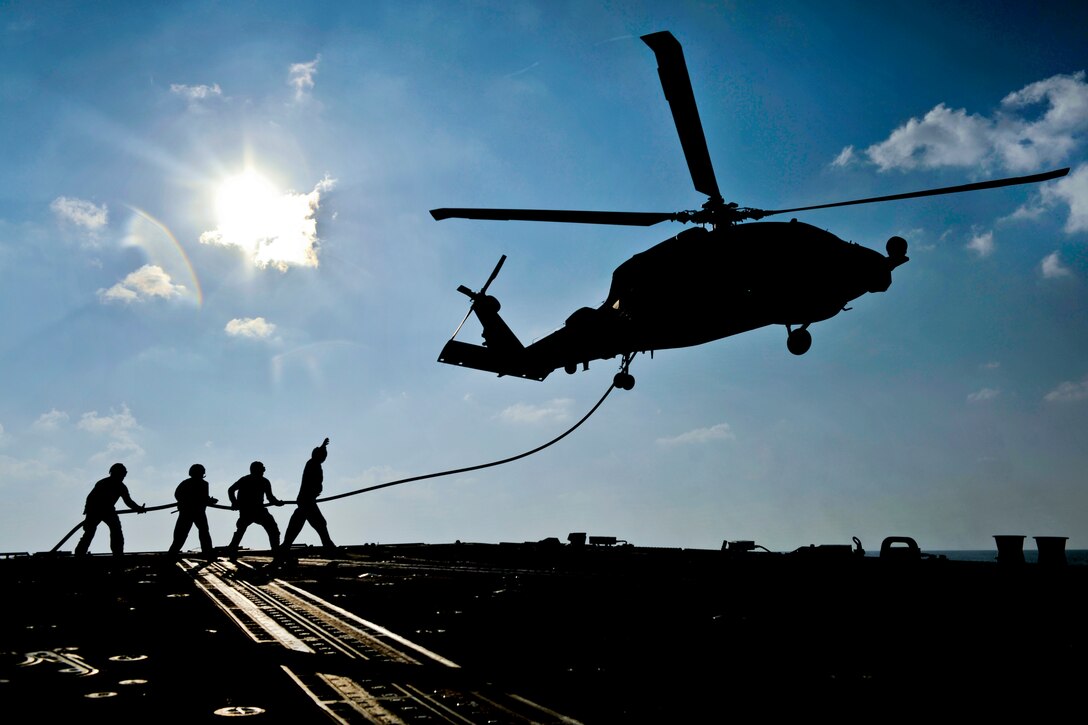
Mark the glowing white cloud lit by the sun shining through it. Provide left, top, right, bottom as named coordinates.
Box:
left=200, top=176, right=336, bottom=272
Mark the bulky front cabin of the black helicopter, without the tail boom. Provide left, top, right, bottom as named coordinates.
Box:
left=604, top=221, right=891, bottom=343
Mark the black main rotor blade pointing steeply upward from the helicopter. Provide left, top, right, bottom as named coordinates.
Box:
left=642, top=30, right=721, bottom=199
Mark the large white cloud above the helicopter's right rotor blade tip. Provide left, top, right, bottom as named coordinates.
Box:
left=865, top=72, right=1088, bottom=172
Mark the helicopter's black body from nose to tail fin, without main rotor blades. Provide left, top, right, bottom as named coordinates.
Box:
left=438, top=221, right=906, bottom=380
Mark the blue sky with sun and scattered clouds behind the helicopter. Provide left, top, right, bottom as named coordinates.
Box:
left=0, top=0, right=1088, bottom=552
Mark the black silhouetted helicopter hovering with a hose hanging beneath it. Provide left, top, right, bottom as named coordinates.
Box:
left=431, top=30, right=1070, bottom=390
